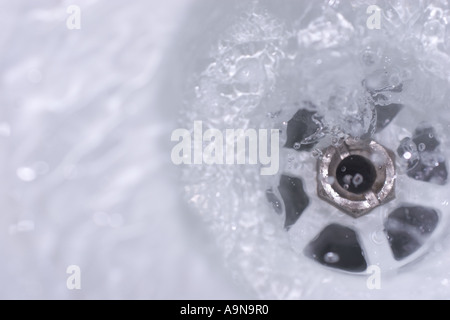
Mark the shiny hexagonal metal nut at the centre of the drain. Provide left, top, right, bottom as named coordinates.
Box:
left=317, top=138, right=396, bottom=218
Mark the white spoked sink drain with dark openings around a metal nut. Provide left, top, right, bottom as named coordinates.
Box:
left=266, top=103, right=447, bottom=274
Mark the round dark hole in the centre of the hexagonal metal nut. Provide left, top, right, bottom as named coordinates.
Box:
left=336, top=155, right=377, bottom=194
